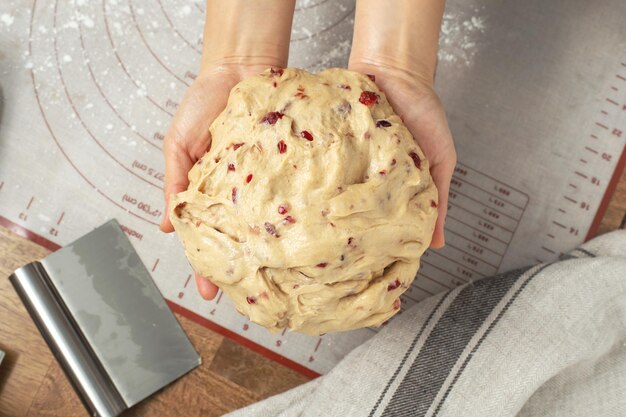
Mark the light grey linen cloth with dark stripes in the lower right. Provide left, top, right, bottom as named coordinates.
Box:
left=229, top=230, right=626, bottom=417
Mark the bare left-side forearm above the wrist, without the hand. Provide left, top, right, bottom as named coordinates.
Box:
left=202, top=0, right=295, bottom=70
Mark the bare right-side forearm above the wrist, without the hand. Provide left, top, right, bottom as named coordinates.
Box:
left=350, top=0, right=445, bottom=84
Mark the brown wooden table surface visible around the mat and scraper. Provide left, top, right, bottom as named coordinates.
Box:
left=0, top=167, right=626, bottom=417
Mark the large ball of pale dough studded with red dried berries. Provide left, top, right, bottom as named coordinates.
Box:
left=170, top=68, right=437, bottom=335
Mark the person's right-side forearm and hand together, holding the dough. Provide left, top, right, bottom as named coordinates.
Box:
left=348, top=0, right=456, bottom=248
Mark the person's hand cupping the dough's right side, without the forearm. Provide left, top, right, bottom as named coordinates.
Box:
left=349, top=63, right=456, bottom=248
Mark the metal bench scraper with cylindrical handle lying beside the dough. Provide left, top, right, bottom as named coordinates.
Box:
left=9, top=220, right=200, bottom=417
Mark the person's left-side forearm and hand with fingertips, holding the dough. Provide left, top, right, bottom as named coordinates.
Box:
left=160, top=0, right=295, bottom=300
